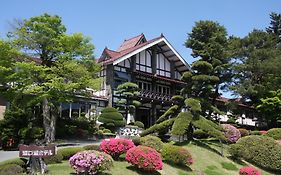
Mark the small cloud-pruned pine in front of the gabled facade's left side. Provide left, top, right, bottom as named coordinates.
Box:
left=117, top=82, right=141, bottom=123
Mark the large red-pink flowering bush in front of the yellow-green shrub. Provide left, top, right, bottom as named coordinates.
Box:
left=125, top=145, right=163, bottom=171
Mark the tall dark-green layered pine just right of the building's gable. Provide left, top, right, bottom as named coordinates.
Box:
left=185, top=21, right=232, bottom=115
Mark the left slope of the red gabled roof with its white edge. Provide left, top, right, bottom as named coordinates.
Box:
left=98, top=36, right=164, bottom=64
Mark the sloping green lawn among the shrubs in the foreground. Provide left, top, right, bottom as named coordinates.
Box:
left=49, top=141, right=271, bottom=175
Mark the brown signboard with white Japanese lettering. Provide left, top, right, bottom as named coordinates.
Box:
left=19, top=145, right=56, bottom=157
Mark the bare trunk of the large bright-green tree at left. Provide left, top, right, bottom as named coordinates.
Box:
left=42, top=97, right=56, bottom=143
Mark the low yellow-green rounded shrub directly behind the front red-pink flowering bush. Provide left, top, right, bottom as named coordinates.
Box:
left=140, top=135, right=163, bottom=152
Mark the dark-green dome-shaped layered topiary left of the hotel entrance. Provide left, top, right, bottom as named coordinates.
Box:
left=98, top=107, right=125, bottom=130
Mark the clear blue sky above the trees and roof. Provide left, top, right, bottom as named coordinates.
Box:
left=0, top=0, right=281, bottom=96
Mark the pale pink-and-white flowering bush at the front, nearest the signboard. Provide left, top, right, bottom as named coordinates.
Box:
left=69, top=150, right=113, bottom=174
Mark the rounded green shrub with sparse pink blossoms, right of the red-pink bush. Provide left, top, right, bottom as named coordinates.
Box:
left=161, top=144, right=193, bottom=166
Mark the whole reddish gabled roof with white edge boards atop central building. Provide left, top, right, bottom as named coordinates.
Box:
left=98, top=34, right=190, bottom=72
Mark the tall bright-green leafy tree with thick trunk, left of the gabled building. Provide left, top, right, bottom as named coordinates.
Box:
left=4, top=14, right=99, bottom=143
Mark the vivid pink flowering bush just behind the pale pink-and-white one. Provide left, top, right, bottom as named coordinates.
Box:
left=100, top=138, right=135, bottom=159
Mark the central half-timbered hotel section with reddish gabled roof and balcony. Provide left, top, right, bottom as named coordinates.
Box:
left=99, top=34, right=189, bottom=127
